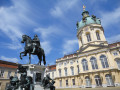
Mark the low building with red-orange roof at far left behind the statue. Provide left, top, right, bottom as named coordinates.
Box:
left=0, top=60, right=18, bottom=90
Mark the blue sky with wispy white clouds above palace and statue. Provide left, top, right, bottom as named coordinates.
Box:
left=0, top=0, right=120, bottom=65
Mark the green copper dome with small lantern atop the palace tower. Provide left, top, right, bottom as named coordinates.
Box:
left=77, top=11, right=101, bottom=30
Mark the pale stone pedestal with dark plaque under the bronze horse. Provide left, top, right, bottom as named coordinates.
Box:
left=19, top=64, right=46, bottom=90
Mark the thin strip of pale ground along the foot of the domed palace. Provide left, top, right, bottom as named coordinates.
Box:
left=56, top=87, right=120, bottom=90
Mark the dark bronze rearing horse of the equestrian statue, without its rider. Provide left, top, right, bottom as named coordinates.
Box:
left=20, top=35, right=46, bottom=65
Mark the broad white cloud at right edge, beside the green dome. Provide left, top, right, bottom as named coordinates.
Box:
left=101, top=7, right=120, bottom=27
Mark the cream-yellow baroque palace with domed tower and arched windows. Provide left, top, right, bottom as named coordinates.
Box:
left=55, top=10, right=120, bottom=88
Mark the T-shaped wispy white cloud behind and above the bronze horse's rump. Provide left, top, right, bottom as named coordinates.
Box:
left=34, top=26, right=62, bottom=54
